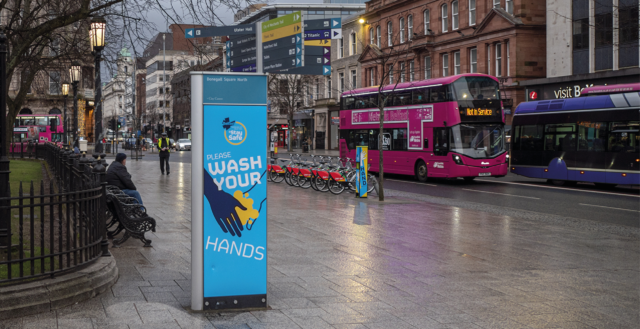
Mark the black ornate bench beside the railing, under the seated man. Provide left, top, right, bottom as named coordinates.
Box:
left=107, top=186, right=156, bottom=248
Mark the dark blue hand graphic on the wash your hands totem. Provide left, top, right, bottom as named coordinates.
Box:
left=203, top=169, right=247, bottom=237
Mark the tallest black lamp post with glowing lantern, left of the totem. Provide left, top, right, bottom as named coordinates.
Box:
left=89, top=16, right=107, bottom=154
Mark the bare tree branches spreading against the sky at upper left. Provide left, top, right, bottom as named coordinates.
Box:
left=0, top=0, right=253, bottom=147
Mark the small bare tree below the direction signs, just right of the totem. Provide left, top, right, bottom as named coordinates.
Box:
left=267, top=74, right=315, bottom=151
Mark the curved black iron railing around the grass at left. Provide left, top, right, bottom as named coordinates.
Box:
left=0, top=144, right=109, bottom=283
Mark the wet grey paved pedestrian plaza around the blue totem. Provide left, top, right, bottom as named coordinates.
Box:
left=0, top=161, right=640, bottom=329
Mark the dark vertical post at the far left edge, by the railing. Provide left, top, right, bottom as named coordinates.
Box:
left=0, top=30, right=11, bottom=247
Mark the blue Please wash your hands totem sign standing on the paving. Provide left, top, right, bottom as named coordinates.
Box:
left=191, top=72, right=267, bottom=310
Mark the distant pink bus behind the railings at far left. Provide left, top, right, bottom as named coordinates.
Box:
left=10, top=114, right=64, bottom=152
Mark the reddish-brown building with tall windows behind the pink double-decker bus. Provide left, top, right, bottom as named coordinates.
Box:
left=360, top=0, right=546, bottom=125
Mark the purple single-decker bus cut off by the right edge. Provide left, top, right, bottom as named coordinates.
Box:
left=511, top=84, right=640, bottom=187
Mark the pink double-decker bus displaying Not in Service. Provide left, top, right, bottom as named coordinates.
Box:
left=340, top=74, right=508, bottom=181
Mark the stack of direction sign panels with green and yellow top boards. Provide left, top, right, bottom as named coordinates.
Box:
left=258, top=11, right=304, bottom=72
